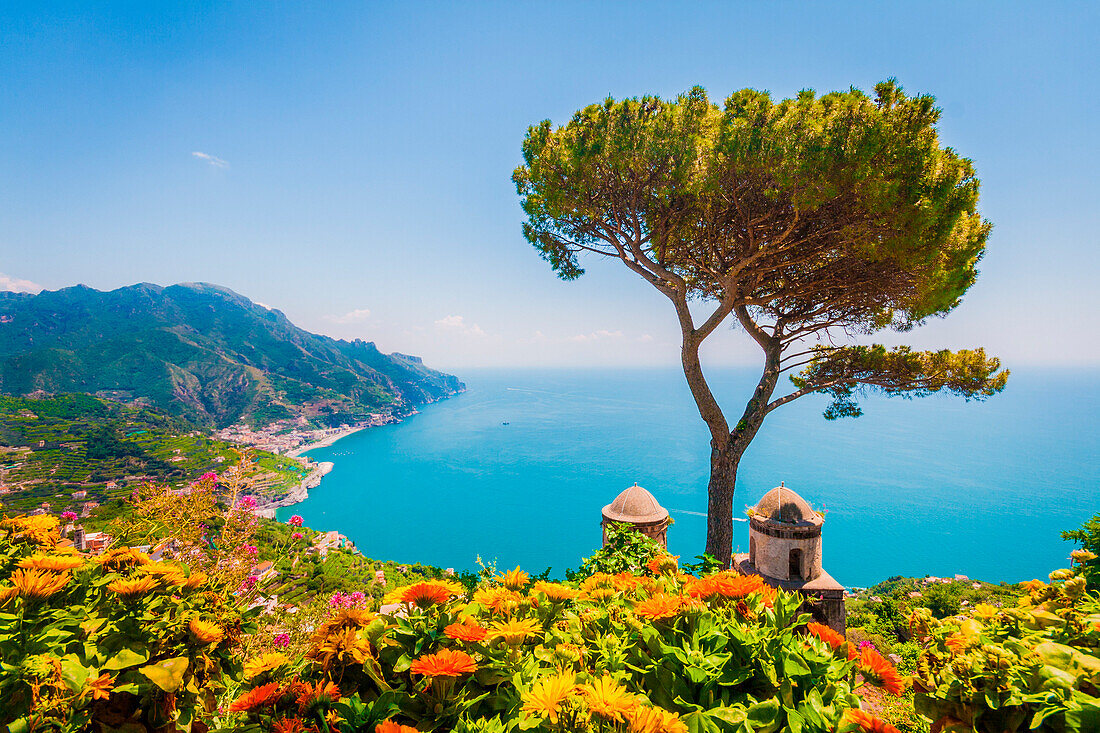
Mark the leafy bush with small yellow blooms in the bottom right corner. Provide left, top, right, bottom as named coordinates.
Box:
left=911, top=550, right=1100, bottom=733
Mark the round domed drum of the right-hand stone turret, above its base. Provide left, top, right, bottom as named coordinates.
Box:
left=749, top=484, right=825, bottom=581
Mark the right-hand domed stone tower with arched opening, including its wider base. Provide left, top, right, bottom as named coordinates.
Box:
left=734, top=484, right=845, bottom=634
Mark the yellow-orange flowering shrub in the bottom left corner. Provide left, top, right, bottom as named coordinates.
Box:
left=0, top=515, right=252, bottom=732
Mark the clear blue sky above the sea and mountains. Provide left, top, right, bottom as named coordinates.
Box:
left=0, top=2, right=1100, bottom=369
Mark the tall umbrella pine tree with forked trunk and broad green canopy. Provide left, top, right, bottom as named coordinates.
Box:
left=513, top=80, right=1008, bottom=560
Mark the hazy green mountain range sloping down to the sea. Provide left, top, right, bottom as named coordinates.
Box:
left=0, top=283, right=464, bottom=427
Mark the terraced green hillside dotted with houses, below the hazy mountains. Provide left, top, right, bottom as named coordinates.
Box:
left=0, top=394, right=306, bottom=512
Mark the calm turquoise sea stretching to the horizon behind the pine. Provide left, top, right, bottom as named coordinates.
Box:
left=278, top=370, right=1100, bottom=586
